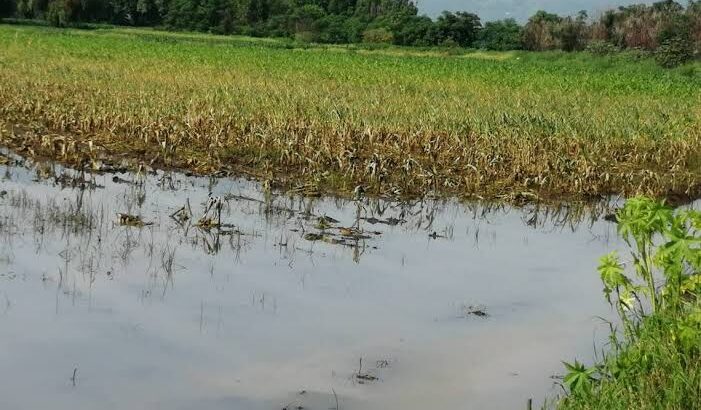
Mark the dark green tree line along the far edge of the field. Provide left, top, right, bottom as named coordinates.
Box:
left=0, top=0, right=701, bottom=62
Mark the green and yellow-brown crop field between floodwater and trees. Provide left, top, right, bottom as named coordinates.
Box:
left=0, top=25, right=701, bottom=200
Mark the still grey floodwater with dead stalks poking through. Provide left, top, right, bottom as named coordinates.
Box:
left=0, top=153, right=644, bottom=410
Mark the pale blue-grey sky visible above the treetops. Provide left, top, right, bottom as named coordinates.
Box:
left=419, top=0, right=645, bottom=21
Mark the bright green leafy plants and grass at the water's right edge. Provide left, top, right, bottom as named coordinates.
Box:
left=558, top=198, right=701, bottom=410
